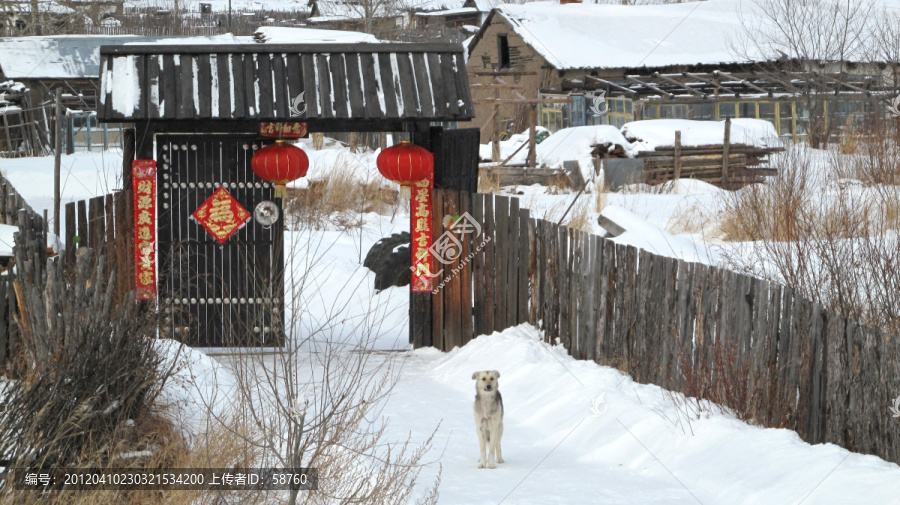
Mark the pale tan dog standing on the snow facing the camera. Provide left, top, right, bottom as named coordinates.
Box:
left=472, top=370, right=503, bottom=468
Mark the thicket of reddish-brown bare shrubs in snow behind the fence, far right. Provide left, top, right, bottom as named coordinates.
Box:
left=721, top=125, right=900, bottom=334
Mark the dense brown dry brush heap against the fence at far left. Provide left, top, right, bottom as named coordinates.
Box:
left=0, top=247, right=183, bottom=503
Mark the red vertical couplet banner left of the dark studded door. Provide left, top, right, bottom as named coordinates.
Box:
left=131, top=160, right=156, bottom=300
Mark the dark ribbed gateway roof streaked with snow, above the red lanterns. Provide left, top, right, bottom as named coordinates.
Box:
left=98, top=44, right=474, bottom=121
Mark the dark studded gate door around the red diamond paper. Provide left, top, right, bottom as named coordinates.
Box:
left=156, top=134, right=284, bottom=347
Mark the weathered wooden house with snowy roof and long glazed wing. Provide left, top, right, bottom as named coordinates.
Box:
left=467, top=0, right=900, bottom=146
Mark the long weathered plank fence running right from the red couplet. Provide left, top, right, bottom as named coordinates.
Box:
left=422, top=189, right=900, bottom=462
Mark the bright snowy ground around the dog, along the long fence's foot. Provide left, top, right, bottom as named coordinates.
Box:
left=384, top=327, right=900, bottom=505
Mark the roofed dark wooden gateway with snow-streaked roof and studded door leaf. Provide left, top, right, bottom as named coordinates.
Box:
left=98, top=44, right=478, bottom=346
